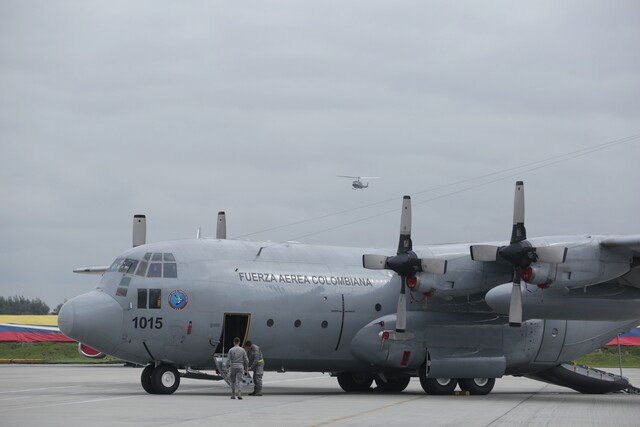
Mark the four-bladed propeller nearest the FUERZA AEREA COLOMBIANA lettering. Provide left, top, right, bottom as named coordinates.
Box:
left=362, top=196, right=447, bottom=338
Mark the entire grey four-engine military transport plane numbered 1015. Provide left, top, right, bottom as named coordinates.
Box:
left=58, top=182, right=640, bottom=394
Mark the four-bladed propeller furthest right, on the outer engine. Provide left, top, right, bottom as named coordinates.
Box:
left=470, top=181, right=567, bottom=327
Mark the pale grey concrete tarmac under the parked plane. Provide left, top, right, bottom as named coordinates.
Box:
left=0, top=365, right=640, bottom=427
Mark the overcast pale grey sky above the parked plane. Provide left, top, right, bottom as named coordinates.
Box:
left=0, top=0, right=640, bottom=307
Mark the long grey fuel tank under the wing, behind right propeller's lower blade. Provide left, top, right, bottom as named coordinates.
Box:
left=485, top=283, right=640, bottom=321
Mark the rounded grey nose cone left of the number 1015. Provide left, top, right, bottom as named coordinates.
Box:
left=58, top=291, right=123, bottom=353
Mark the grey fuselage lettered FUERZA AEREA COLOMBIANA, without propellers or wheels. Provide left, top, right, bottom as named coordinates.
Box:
left=60, top=236, right=640, bottom=377
